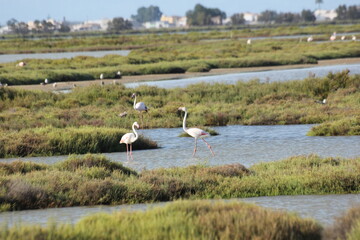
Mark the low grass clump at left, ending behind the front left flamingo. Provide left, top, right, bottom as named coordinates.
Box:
left=0, top=127, right=157, bottom=157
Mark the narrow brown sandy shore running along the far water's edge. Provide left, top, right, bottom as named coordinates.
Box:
left=10, top=58, right=360, bottom=91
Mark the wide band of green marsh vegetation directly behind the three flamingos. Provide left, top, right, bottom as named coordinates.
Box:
left=0, top=71, right=360, bottom=157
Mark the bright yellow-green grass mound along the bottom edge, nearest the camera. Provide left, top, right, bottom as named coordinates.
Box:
left=0, top=201, right=322, bottom=240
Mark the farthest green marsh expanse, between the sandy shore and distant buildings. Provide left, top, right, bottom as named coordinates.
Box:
left=0, top=25, right=360, bottom=85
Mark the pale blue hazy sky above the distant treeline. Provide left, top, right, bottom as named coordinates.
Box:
left=0, top=0, right=360, bottom=25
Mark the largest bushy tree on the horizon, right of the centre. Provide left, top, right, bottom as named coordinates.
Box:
left=186, top=4, right=226, bottom=26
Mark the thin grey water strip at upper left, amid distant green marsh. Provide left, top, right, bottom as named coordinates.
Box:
left=0, top=50, right=130, bottom=63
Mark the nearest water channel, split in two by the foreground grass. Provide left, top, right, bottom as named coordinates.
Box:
left=0, top=194, right=360, bottom=226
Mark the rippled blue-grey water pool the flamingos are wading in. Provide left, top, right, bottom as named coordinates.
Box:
left=0, top=125, right=360, bottom=171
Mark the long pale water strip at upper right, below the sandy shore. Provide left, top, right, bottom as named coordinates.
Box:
left=125, top=63, right=360, bottom=88
